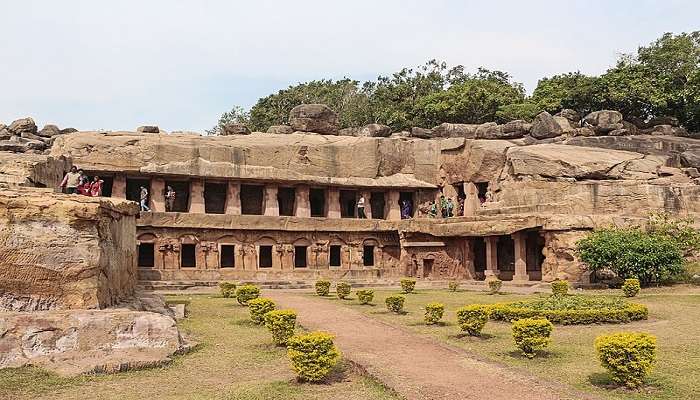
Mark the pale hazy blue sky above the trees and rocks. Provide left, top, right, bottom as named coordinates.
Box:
left=0, top=0, right=700, bottom=131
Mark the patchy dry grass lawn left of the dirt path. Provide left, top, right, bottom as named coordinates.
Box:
left=0, top=295, right=395, bottom=400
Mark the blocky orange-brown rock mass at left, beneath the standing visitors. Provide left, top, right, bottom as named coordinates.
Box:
left=0, top=189, right=138, bottom=311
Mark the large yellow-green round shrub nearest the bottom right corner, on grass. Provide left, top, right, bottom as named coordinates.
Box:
left=594, top=332, right=656, bottom=388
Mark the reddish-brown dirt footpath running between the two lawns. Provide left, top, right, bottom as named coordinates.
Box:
left=265, top=290, right=593, bottom=400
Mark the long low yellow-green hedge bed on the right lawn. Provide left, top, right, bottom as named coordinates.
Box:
left=489, top=295, right=649, bottom=325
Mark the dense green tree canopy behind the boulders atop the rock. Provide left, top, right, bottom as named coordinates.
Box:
left=208, top=31, right=700, bottom=134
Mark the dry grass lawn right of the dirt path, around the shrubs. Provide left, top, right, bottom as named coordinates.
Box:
left=328, top=286, right=700, bottom=399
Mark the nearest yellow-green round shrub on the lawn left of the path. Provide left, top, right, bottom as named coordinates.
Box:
left=287, top=332, right=340, bottom=382
